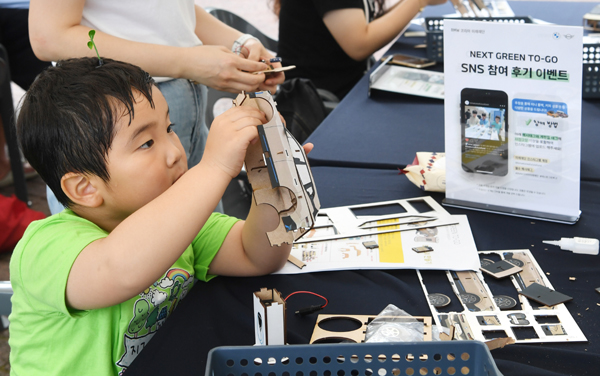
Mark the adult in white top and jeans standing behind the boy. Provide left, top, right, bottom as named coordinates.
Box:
left=30, top=0, right=285, bottom=211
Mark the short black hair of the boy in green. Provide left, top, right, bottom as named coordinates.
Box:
left=17, top=57, right=154, bottom=207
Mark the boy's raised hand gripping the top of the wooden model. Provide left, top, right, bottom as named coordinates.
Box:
left=202, top=106, right=267, bottom=179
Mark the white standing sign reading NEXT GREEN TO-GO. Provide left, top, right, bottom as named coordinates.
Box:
left=444, top=20, right=583, bottom=222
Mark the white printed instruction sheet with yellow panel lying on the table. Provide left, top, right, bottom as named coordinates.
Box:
left=278, top=197, right=480, bottom=274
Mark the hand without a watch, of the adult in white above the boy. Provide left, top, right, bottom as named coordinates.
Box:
left=181, top=46, right=268, bottom=93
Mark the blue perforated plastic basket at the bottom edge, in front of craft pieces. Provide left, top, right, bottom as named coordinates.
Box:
left=205, top=341, right=502, bottom=376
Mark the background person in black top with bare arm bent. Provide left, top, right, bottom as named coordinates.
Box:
left=273, top=0, right=446, bottom=99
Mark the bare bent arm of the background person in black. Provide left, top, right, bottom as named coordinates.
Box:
left=323, top=0, right=446, bottom=61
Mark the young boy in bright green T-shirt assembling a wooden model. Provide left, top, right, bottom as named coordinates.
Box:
left=10, top=58, right=300, bottom=376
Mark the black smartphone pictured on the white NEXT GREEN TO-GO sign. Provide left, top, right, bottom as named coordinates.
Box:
left=460, top=88, right=508, bottom=176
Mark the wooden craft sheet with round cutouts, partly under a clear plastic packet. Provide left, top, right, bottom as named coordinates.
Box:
left=309, top=315, right=432, bottom=344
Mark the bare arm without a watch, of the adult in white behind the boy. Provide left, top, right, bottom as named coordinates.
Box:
left=29, top=0, right=276, bottom=92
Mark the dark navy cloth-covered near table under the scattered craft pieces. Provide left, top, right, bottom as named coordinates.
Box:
left=126, top=167, right=600, bottom=375
